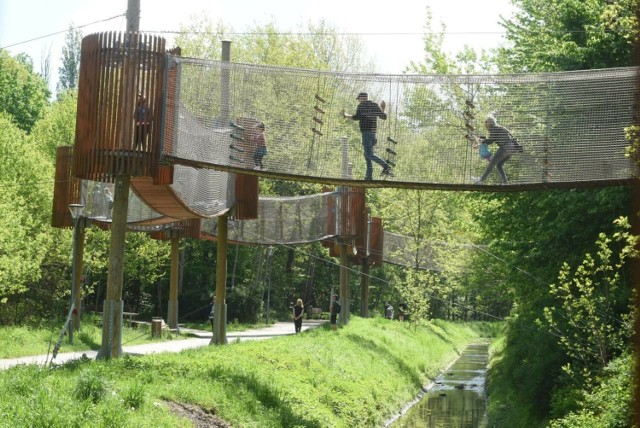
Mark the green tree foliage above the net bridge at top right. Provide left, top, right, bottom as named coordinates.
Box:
left=499, top=0, right=639, bottom=72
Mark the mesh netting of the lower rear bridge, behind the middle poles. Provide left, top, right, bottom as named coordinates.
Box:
left=202, top=192, right=339, bottom=245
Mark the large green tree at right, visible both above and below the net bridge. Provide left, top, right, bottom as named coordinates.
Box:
left=478, top=0, right=638, bottom=426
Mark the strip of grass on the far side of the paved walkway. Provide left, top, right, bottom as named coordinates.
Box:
left=0, top=314, right=265, bottom=359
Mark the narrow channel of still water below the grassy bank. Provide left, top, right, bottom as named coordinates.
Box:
left=391, top=343, right=489, bottom=428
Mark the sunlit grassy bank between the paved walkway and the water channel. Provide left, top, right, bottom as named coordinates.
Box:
left=0, top=317, right=499, bottom=427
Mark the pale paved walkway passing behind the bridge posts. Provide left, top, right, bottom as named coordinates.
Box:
left=0, top=320, right=328, bottom=370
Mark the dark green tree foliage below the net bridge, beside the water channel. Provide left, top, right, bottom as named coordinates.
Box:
left=484, top=187, right=631, bottom=426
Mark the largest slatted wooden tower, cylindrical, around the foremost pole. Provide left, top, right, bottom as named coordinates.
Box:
left=74, top=32, right=166, bottom=182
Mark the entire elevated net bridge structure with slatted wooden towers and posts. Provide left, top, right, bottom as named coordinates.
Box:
left=52, top=33, right=637, bottom=358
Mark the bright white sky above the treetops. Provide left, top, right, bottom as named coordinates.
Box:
left=0, top=0, right=514, bottom=89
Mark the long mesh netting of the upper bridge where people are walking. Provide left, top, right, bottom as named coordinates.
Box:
left=164, top=56, right=637, bottom=188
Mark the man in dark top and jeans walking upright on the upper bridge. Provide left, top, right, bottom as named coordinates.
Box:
left=342, top=92, right=391, bottom=181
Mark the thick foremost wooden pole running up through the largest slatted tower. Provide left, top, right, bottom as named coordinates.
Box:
left=98, top=0, right=140, bottom=359
